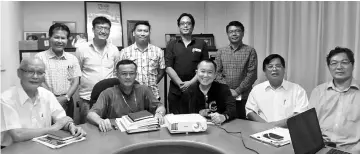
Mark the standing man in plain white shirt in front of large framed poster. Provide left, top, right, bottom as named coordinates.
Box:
left=76, top=16, right=119, bottom=124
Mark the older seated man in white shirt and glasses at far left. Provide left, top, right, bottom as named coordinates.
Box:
left=1, top=58, right=86, bottom=146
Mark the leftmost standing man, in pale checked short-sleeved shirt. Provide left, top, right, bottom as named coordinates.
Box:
left=35, top=23, right=81, bottom=118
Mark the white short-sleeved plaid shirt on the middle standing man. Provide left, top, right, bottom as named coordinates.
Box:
left=119, top=43, right=165, bottom=98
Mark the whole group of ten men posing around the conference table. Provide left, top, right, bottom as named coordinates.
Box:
left=1, top=13, right=360, bottom=151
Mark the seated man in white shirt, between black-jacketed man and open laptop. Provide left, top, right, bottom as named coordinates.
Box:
left=245, top=54, right=309, bottom=127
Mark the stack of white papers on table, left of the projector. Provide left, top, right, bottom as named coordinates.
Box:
left=115, top=110, right=160, bottom=133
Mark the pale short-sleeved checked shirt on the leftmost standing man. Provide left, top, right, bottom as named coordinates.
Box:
left=35, top=49, right=81, bottom=95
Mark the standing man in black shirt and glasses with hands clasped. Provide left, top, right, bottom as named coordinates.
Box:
left=165, top=13, right=209, bottom=114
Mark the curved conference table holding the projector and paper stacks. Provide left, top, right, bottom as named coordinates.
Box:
left=1, top=119, right=294, bottom=154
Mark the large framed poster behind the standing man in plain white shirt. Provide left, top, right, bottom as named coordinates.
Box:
left=84, top=1, right=124, bottom=47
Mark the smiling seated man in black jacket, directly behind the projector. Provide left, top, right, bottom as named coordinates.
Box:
left=182, top=60, right=236, bottom=124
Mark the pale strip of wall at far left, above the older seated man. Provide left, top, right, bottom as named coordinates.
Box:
left=0, top=1, right=23, bottom=92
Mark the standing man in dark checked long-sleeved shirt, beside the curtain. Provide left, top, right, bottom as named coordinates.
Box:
left=215, top=21, right=257, bottom=119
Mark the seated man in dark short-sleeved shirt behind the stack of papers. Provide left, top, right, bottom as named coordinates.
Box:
left=87, top=59, right=165, bottom=132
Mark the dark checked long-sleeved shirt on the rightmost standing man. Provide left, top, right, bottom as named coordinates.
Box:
left=215, top=44, right=257, bottom=97
